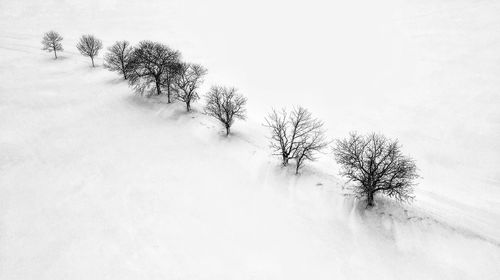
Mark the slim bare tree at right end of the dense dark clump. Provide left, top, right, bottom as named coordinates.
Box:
left=175, top=63, right=207, bottom=112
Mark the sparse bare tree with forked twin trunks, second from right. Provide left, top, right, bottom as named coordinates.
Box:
left=265, top=107, right=328, bottom=173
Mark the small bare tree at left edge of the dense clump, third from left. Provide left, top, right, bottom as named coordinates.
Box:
left=104, top=41, right=133, bottom=80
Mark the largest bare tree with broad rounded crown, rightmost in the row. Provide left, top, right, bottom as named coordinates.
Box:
left=333, top=133, right=419, bottom=207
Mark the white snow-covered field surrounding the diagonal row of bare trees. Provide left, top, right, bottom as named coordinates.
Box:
left=0, top=0, right=500, bottom=280
